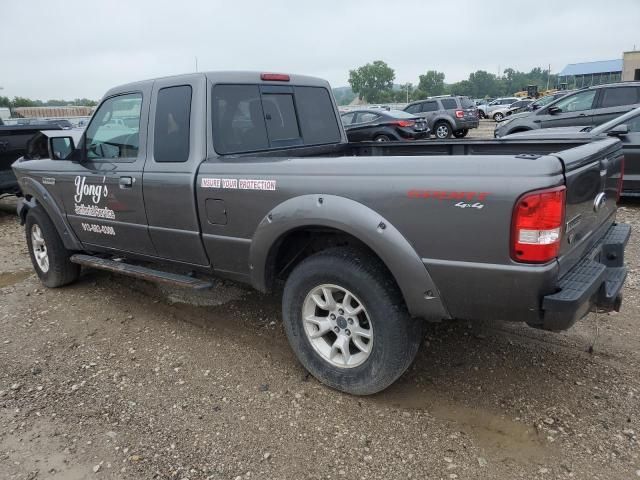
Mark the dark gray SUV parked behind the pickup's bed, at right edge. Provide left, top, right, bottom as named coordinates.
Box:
left=494, top=82, right=640, bottom=138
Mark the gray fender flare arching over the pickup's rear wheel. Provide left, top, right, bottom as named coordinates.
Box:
left=249, top=194, right=450, bottom=321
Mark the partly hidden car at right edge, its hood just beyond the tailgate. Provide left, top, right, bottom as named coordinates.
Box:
left=504, top=107, right=640, bottom=197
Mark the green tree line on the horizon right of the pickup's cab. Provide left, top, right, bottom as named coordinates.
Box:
left=336, top=60, right=557, bottom=105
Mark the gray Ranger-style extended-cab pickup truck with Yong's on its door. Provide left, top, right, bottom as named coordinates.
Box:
left=13, top=72, right=630, bottom=394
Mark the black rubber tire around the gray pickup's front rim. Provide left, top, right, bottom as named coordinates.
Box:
left=25, top=206, right=80, bottom=288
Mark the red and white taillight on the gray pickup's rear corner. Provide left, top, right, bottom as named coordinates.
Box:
left=511, top=185, right=566, bottom=263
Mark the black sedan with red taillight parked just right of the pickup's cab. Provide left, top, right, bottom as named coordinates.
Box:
left=340, top=108, right=429, bottom=142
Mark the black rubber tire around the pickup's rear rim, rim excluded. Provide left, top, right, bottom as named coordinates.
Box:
left=282, top=248, right=422, bottom=395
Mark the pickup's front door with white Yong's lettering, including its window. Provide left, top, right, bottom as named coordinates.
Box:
left=58, top=86, right=155, bottom=255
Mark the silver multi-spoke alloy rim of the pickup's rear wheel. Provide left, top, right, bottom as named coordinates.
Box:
left=302, top=284, right=373, bottom=368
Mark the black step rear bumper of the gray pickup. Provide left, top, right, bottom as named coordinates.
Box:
left=531, top=224, right=631, bottom=330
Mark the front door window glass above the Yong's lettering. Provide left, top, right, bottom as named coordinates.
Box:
left=85, top=93, right=142, bottom=161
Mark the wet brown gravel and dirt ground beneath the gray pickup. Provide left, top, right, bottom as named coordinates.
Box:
left=0, top=191, right=640, bottom=480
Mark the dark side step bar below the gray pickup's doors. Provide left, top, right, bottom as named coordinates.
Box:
left=69, top=254, right=213, bottom=290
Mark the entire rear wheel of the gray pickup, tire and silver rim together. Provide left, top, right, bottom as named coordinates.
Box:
left=282, top=248, right=422, bottom=395
